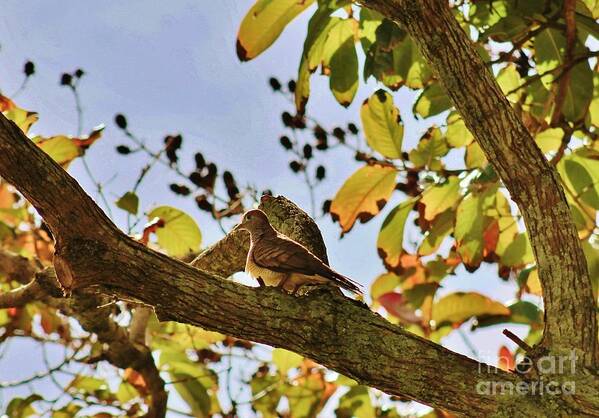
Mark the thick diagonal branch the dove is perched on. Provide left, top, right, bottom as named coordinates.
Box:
left=0, top=113, right=543, bottom=416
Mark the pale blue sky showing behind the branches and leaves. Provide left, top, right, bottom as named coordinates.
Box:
left=0, top=0, right=526, bottom=416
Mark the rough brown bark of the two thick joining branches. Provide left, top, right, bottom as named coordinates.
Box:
left=0, top=0, right=599, bottom=417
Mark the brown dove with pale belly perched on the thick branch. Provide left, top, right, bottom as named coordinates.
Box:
left=234, top=209, right=362, bottom=295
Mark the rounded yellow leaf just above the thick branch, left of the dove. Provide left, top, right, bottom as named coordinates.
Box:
left=148, top=206, right=202, bottom=257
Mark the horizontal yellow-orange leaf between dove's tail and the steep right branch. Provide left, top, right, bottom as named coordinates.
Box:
left=431, top=292, right=511, bottom=328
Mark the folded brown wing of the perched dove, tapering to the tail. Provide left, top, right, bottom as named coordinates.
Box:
left=253, top=235, right=361, bottom=293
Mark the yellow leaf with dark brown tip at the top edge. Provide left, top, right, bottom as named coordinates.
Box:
left=237, top=0, right=314, bottom=61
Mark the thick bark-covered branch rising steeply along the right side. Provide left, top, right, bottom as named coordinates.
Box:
left=362, top=0, right=598, bottom=367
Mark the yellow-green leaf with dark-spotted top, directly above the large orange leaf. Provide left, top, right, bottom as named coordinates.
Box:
left=360, top=90, right=404, bottom=158
